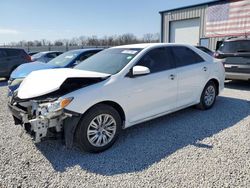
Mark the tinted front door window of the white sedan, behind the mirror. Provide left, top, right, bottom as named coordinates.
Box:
left=137, top=47, right=174, bottom=73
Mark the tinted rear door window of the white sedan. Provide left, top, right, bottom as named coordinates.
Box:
left=173, top=46, right=204, bottom=67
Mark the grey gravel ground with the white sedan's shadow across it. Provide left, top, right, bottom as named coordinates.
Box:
left=0, top=79, right=250, bottom=187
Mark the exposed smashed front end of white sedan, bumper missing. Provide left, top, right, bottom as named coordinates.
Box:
left=8, top=97, right=73, bottom=143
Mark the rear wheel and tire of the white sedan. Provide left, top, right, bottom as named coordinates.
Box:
left=197, top=81, right=217, bottom=110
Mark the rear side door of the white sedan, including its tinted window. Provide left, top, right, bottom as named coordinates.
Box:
left=173, top=46, right=210, bottom=108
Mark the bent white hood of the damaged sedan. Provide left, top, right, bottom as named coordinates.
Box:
left=17, top=68, right=110, bottom=99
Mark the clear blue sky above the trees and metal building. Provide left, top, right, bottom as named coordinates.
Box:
left=0, top=0, right=213, bottom=44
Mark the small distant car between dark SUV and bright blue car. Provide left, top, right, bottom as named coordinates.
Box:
left=31, top=51, right=63, bottom=63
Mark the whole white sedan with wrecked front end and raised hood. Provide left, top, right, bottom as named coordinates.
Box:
left=9, top=44, right=225, bottom=152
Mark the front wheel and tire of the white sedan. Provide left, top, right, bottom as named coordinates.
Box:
left=75, top=104, right=122, bottom=153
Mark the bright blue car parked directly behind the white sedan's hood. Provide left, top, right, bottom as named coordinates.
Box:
left=8, top=48, right=102, bottom=95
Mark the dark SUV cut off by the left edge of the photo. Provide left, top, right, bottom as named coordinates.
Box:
left=0, top=48, right=31, bottom=78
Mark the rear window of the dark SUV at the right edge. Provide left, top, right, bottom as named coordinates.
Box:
left=219, top=40, right=250, bottom=53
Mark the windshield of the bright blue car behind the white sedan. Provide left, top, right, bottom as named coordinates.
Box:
left=48, top=51, right=81, bottom=67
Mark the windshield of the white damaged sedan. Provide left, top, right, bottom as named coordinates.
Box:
left=75, top=48, right=142, bottom=75
